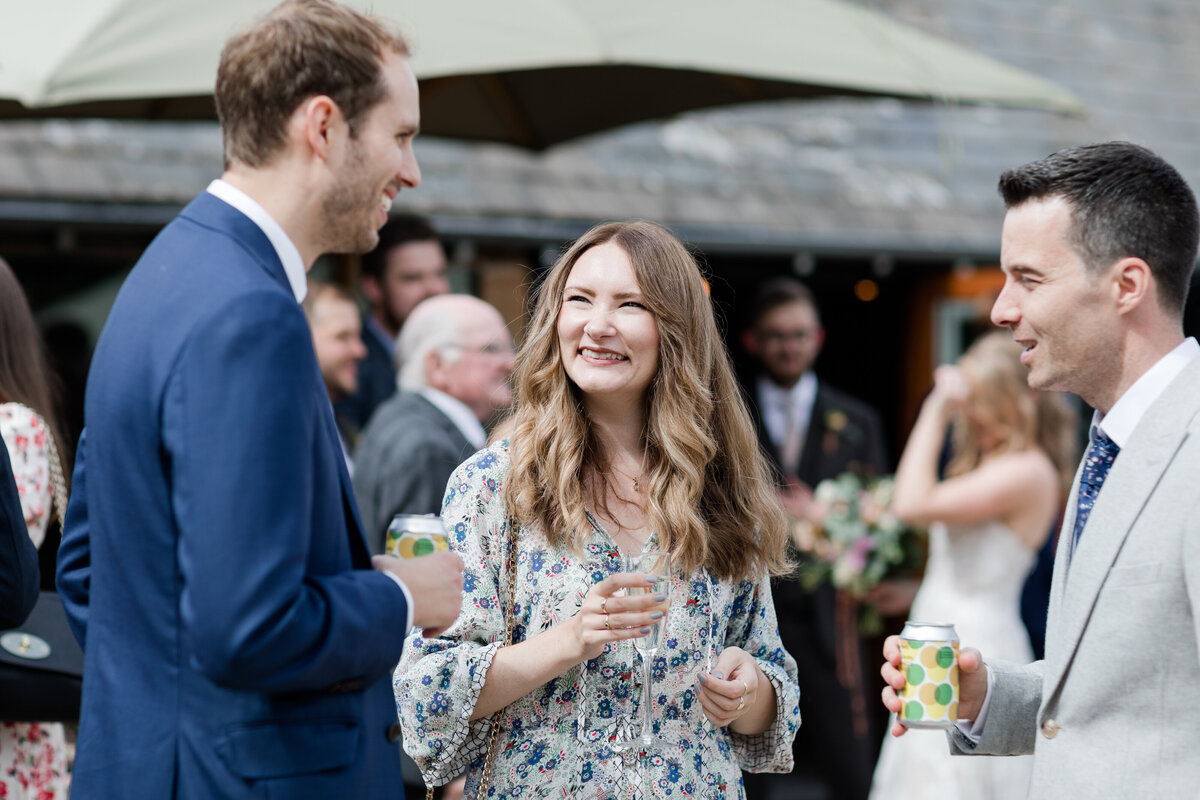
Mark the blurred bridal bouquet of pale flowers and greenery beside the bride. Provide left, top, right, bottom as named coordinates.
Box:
left=792, top=473, right=925, bottom=628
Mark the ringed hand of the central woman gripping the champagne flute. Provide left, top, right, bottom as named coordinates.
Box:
left=572, top=572, right=671, bottom=661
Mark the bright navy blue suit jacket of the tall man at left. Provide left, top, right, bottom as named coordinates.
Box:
left=58, top=193, right=407, bottom=800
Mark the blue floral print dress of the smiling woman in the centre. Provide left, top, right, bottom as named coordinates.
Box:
left=394, top=443, right=800, bottom=800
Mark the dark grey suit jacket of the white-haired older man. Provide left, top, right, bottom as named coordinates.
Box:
left=354, top=392, right=475, bottom=553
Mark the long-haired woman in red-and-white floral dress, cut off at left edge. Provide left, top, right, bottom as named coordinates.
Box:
left=0, top=259, right=68, bottom=800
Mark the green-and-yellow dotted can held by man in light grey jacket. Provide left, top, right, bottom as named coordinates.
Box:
left=899, top=620, right=959, bottom=728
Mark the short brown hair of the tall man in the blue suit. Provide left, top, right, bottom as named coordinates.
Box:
left=215, top=0, right=408, bottom=168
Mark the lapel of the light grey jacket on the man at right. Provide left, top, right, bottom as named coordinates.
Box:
left=1043, top=359, right=1200, bottom=702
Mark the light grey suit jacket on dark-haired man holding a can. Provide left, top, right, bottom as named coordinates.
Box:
left=952, top=359, right=1200, bottom=799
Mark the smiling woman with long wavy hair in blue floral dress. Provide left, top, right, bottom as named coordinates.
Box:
left=396, top=222, right=799, bottom=798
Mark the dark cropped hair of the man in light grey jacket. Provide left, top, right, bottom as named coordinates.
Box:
left=1000, top=142, right=1200, bottom=315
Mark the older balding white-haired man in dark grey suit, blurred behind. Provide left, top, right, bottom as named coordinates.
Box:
left=354, top=294, right=512, bottom=553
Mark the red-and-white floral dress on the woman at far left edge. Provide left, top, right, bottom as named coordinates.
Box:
left=0, top=403, right=68, bottom=800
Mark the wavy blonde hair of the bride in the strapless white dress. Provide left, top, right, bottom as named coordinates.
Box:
left=946, top=331, right=1079, bottom=498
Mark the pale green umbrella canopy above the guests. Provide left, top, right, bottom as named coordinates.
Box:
left=0, top=0, right=1082, bottom=149
